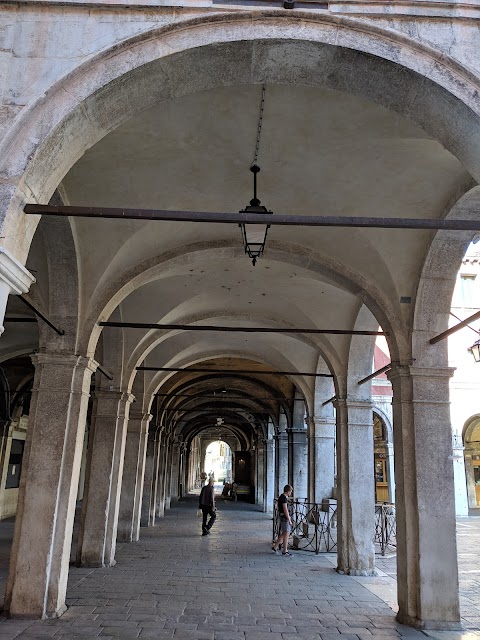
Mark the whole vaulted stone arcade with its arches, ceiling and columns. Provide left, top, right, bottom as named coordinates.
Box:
left=0, top=0, right=480, bottom=629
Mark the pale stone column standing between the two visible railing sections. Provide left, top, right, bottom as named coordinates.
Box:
left=335, top=400, right=375, bottom=576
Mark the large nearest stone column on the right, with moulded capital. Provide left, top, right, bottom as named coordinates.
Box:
left=387, top=366, right=460, bottom=629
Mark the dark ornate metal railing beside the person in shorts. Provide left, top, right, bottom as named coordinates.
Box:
left=273, top=499, right=397, bottom=556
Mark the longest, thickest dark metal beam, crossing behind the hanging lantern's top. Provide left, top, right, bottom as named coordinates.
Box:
left=23, top=204, right=480, bottom=231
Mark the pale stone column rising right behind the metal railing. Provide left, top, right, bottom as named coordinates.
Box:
left=307, top=415, right=335, bottom=503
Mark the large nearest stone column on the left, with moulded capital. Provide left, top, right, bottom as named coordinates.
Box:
left=5, top=353, right=96, bottom=618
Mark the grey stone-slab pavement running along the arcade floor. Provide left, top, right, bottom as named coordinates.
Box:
left=0, top=501, right=479, bottom=640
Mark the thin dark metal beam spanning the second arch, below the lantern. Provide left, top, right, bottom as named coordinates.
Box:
left=98, top=322, right=389, bottom=336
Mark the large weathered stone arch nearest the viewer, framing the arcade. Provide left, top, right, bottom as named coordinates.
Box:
left=0, top=11, right=480, bottom=268
